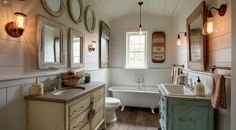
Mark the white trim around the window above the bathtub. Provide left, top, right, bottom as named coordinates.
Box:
left=125, top=31, right=148, bottom=69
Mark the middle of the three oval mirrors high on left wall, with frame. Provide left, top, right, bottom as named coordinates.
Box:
left=68, top=0, right=83, bottom=23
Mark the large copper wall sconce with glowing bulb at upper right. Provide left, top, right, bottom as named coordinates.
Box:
left=202, top=4, right=227, bottom=35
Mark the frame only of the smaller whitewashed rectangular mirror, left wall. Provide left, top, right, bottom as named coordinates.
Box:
left=68, top=28, right=85, bottom=68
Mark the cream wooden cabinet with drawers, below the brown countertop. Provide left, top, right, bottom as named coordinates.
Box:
left=27, top=87, right=105, bottom=130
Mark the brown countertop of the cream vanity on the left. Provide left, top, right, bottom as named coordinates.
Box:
left=25, top=82, right=105, bottom=103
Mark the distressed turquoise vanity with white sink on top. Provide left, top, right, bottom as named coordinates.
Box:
left=159, top=84, right=214, bottom=130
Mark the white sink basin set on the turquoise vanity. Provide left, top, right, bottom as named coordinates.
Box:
left=161, top=84, right=195, bottom=96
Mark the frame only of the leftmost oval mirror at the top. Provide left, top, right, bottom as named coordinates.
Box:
left=41, top=0, right=65, bottom=17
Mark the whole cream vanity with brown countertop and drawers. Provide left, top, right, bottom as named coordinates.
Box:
left=25, top=82, right=105, bottom=130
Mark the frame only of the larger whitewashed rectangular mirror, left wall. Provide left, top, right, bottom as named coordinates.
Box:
left=37, top=15, right=67, bottom=69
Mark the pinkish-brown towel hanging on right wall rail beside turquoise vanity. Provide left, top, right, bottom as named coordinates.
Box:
left=211, top=74, right=227, bottom=109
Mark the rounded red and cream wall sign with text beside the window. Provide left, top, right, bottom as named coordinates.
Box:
left=152, top=32, right=166, bottom=63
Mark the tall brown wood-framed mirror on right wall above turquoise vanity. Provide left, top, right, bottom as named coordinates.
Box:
left=187, top=1, right=207, bottom=71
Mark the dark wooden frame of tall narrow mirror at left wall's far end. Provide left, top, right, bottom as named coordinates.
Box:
left=99, top=21, right=110, bottom=68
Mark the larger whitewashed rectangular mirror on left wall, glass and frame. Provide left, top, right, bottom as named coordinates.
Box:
left=37, top=16, right=66, bottom=69
